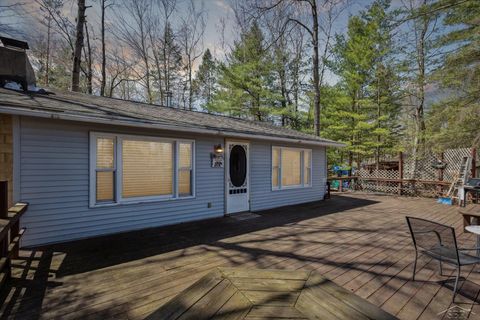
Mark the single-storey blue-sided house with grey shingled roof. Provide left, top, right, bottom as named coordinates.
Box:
left=0, top=40, right=341, bottom=246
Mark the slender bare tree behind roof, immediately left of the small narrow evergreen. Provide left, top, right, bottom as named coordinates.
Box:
left=179, top=0, right=206, bottom=110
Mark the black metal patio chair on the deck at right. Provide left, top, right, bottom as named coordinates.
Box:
left=407, top=217, right=480, bottom=301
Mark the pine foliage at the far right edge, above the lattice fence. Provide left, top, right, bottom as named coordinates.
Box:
left=428, top=1, right=480, bottom=149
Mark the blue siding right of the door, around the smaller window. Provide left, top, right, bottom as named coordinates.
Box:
left=250, top=141, right=327, bottom=211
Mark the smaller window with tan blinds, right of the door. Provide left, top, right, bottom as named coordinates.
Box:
left=272, top=147, right=312, bottom=190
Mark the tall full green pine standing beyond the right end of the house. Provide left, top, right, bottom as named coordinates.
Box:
left=322, top=0, right=400, bottom=166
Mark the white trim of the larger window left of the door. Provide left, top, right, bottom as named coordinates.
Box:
left=89, top=131, right=196, bottom=208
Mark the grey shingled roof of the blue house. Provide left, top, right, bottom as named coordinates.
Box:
left=0, top=88, right=343, bottom=147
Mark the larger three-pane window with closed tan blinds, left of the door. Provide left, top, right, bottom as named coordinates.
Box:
left=90, top=133, right=194, bottom=206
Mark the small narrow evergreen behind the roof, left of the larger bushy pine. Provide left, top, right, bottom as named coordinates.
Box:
left=193, top=49, right=217, bottom=110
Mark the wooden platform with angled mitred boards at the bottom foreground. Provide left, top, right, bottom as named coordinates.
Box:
left=147, top=268, right=397, bottom=320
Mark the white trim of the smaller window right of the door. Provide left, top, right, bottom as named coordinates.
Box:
left=270, top=146, right=313, bottom=191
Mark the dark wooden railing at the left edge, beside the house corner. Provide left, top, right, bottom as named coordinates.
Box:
left=0, top=181, right=28, bottom=288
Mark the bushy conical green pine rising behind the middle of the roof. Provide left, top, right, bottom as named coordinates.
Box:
left=208, top=23, right=277, bottom=121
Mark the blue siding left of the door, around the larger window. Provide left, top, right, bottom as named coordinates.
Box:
left=20, top=118, right=224, bottom=246
